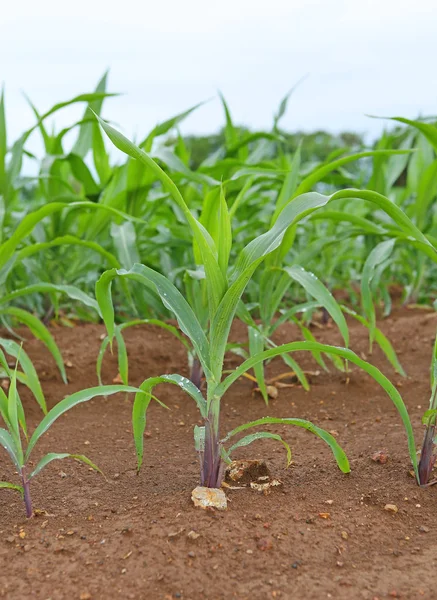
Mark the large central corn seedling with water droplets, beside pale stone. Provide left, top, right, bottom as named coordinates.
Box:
left=96, top=120, right=428, bottom=488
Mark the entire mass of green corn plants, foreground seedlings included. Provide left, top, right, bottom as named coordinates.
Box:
left=0, top=76, right=437, bottom=516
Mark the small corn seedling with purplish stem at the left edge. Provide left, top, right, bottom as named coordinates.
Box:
left=0, top=360, right=150, bottom=517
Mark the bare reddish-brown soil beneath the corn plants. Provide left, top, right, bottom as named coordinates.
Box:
left=0, top=310, right=437, bottom=600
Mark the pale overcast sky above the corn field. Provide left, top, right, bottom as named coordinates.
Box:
left=0, top=0, right=437, bottom=149
